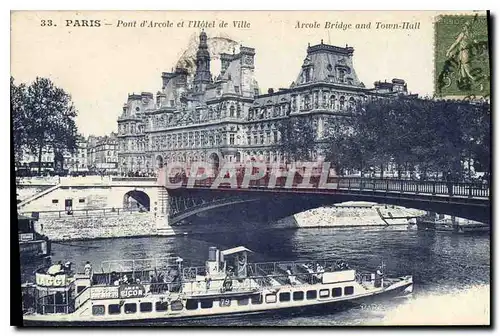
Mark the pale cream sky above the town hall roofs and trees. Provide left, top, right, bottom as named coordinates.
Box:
left=11, top=11, right=480, bottom=136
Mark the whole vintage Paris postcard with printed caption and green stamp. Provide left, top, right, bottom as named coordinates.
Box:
left=10, top=11, right=492, bottom=327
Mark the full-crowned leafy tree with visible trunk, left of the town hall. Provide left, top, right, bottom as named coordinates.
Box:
left=25, top=77, right=77, bottom=173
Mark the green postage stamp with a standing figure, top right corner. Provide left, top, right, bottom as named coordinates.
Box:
left=434, top=15, right=490, bottom=98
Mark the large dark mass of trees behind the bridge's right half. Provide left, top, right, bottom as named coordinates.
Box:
left=329, top=97, right=491, bottom=181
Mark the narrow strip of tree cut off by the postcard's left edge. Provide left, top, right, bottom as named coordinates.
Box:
left=10, top=77, right=27, bottom=164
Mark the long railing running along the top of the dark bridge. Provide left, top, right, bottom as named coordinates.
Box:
left=170, top=175, right=490, bottom=197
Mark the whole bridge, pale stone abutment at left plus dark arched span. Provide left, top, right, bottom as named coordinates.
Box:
left=18, top=177, right=490, bottom=238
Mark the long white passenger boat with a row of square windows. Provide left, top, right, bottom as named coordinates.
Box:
left=22, top=246, right=413, bottom=325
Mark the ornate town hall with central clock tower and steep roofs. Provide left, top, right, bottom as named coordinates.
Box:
left=117, top=32, right=407, bottom=174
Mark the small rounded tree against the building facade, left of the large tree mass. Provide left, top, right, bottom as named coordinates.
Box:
left=277, top=116, right=318, bottom=161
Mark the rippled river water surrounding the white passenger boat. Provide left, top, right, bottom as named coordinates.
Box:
left=22, top=224, right=490, bottom=326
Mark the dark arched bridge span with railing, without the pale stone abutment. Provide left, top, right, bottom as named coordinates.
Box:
left=168, top=177, right=490, bottom=225
